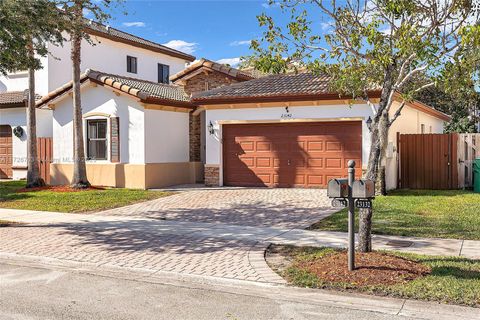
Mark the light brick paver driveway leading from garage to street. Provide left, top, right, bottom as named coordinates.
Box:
left=0, top=188, right=332, bottom=282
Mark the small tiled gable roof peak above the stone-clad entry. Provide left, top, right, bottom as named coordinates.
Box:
left=170, top=58, right=255, bottom=82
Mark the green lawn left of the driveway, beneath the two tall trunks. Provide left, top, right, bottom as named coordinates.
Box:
left=0, top=181, right=169, bottom=212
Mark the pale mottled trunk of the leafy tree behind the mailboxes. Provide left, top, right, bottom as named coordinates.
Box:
left=358, top=65, right=395, bottom=252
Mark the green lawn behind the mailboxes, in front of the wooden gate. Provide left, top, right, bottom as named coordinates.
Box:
left=311, top=190, right=480, bottom=240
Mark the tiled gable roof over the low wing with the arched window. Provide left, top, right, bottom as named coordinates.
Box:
left=37, top=69, right=193, bottom=108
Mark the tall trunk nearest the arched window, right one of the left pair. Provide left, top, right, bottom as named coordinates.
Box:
left=71, top=2, right=90, bottom=188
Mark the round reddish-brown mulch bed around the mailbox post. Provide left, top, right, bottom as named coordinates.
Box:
left=297, top=251, right=431, bottom=286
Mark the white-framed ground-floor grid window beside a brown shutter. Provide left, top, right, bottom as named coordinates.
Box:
left=87, top=119, right=107, bottom=160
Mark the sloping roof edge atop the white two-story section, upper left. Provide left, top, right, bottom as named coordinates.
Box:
left=86, top=20, right=195, bottom=61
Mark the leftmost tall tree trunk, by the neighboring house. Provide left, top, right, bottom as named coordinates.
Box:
left=27, top=43, right=45, bottom=188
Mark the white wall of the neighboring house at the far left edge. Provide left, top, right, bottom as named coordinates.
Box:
left=0, top=107, right=52, bottom=179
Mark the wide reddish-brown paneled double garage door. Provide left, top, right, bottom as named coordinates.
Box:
left=223, top=121, right=362, bottom=188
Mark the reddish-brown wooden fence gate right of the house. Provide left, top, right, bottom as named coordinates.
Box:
left=397, top=133, right=458, bottom=189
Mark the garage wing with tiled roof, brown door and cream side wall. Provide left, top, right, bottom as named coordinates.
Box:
left=192, top=73, right=450, bottom=189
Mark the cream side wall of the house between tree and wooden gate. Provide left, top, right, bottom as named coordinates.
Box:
left=385, top=102, right=445, bottom=190
